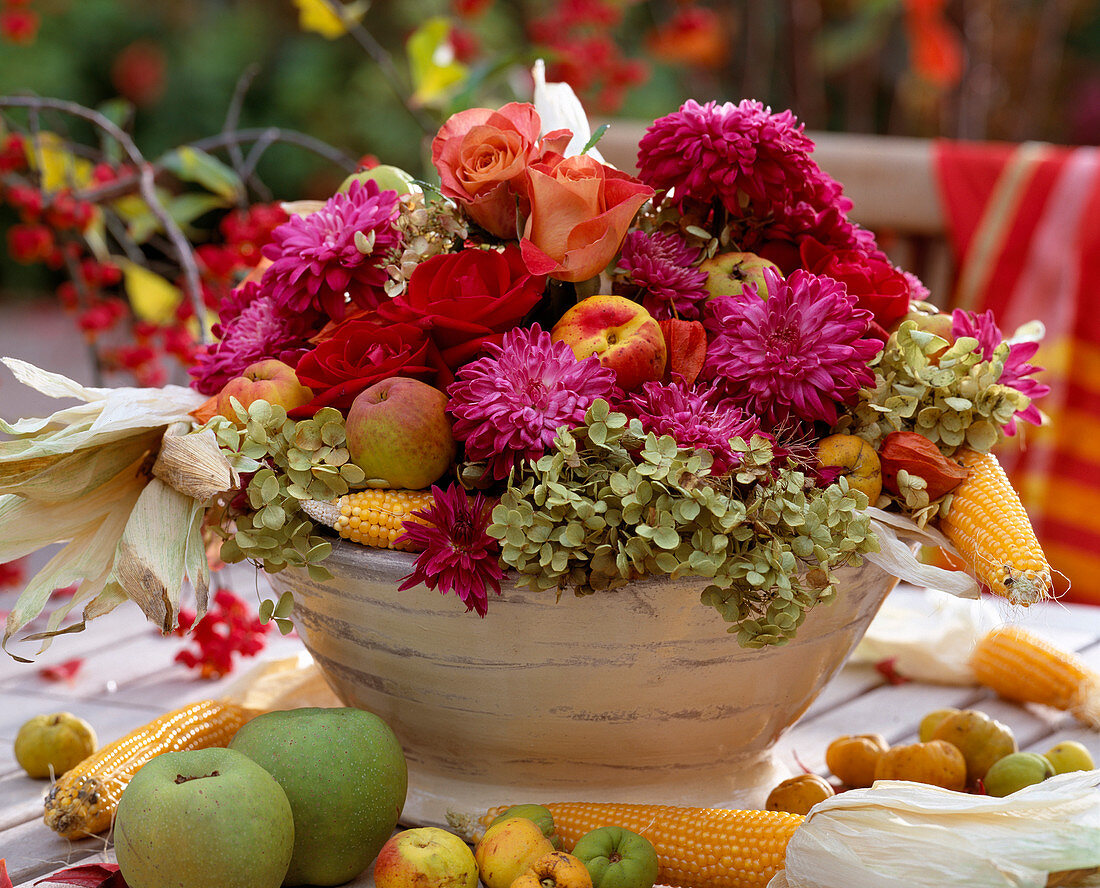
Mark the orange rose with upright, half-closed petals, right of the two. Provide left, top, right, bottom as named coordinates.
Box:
left=519, top=154, right=653, bottom=283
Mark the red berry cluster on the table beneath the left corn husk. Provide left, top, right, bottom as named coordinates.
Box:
left=175, top=589, right=271, bottom=679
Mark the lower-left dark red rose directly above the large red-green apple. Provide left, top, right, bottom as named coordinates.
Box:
left=292, top=315, right=452, bottom=419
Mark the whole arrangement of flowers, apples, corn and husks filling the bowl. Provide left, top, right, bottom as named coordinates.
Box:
left=0, top=73, right=1051, bottom=646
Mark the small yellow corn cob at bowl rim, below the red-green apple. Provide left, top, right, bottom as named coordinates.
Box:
left=301, top=490, right=432, bottom=551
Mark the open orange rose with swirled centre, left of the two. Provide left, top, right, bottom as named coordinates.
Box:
left=431, top=102, right=573, bottom=239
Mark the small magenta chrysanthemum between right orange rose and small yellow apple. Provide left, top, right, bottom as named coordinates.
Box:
left=619, top=230, right=707, bottom=320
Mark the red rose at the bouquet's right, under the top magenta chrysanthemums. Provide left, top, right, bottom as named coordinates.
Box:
left=800, top=238, right=910, bottom=328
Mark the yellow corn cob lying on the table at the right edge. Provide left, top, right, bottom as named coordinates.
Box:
left=970, top=626, right=1100, bottom=728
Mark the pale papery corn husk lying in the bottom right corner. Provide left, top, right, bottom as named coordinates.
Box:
left=769, top=770, right=1100, bottom=888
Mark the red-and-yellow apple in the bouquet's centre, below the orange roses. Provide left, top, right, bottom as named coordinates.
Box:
left=550, top=294, right=667, bottom=392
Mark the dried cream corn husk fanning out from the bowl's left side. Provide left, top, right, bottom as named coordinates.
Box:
left=0, top=358, right=214, bottom=659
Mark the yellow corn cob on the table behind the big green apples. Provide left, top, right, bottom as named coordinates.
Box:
left=45, top=700, right=259, bottom=838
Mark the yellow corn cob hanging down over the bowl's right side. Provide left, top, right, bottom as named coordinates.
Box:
left=939, top=450, right=1052, bottom=606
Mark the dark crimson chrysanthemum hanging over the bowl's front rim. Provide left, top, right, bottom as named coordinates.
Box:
left=397, top=482, right=504, bottom=616
